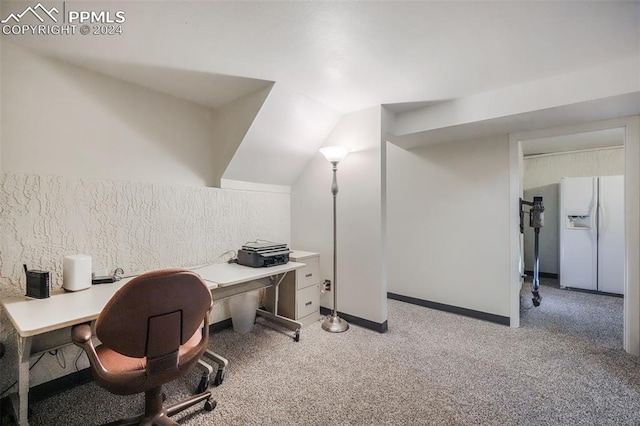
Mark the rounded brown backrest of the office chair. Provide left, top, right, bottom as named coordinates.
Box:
left=95, top=269, right=212, bottom=358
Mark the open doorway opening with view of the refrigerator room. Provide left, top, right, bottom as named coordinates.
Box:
left=521, top=127, right=625, bottom=349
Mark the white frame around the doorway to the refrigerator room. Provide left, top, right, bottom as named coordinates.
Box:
left=509, top=116, right=640, bottom=356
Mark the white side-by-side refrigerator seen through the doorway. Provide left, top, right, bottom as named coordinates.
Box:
left=560, top=176, right=625, bottom=294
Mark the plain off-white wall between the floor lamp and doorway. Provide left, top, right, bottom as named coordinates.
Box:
left=387, top=136, right=510, bottom=317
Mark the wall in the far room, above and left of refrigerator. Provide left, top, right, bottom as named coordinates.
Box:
left=523, top=148, right=624, bottom=274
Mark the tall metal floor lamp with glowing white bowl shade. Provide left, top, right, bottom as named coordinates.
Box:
left=320, top=146, right=351, bottom=333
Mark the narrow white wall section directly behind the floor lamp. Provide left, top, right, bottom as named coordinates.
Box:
left=291, top=106, right=387, bottom=324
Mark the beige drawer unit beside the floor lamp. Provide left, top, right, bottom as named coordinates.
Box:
left=265, top=251, right=320, bottom=327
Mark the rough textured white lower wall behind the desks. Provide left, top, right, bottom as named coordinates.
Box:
left=0, top=173, right=291, bottom=389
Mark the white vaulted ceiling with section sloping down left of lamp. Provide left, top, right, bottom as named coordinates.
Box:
left=3, top=1, right=640, bottom=185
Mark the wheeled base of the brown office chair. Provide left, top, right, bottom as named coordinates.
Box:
left=104, top=388, right=217, bottom=426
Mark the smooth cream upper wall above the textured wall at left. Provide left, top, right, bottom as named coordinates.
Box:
left=0, top=41, right=220, bottom=186
